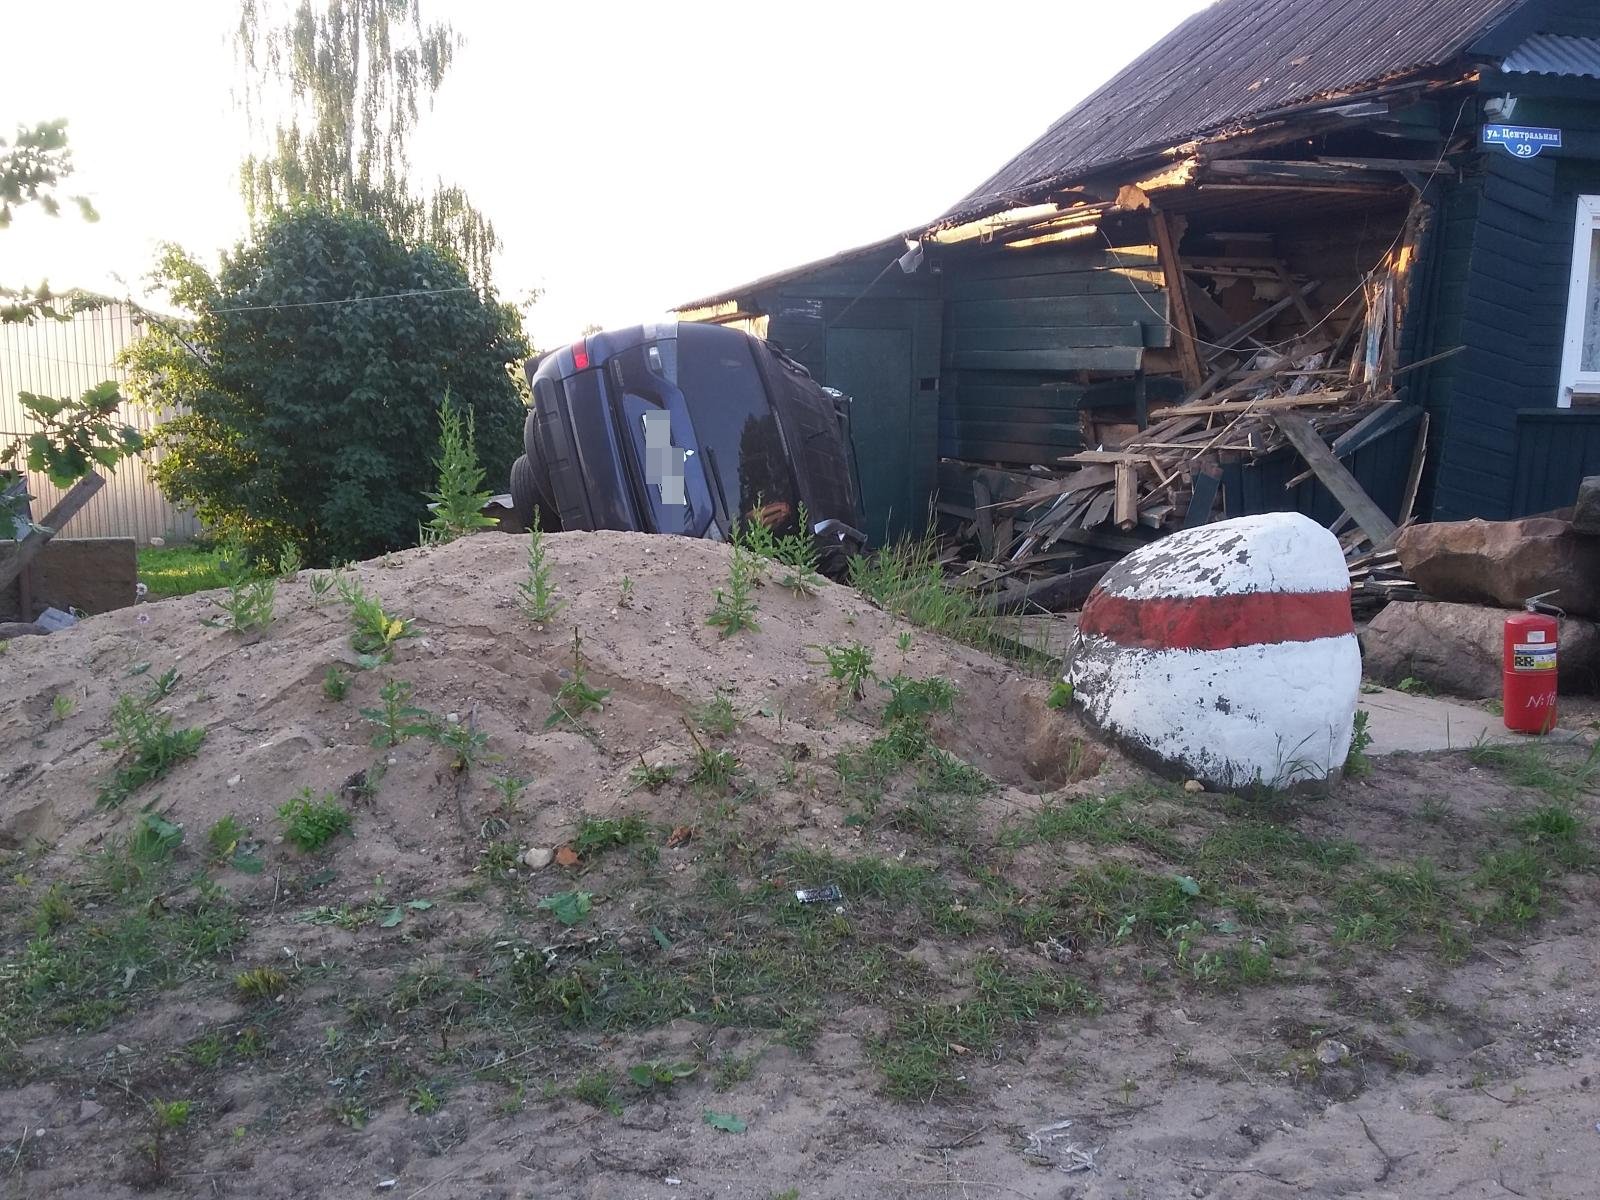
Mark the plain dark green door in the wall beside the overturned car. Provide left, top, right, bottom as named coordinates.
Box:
left=827, top=330, right=928, bottom=546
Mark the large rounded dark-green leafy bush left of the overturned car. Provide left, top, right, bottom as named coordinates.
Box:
left=128, top=206, right=528, bottom=566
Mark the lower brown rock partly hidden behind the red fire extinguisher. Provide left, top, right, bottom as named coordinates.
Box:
left=1362, top=600, right=1600, bottom=699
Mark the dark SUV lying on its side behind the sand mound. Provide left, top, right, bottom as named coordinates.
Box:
left=510, top=322, right=866, bottom=573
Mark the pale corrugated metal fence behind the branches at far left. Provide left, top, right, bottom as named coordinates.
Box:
left=0, top=304, right=200, bottom=544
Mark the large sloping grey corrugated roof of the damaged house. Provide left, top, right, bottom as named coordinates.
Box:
left=946, top=0, right=1529, bottom=221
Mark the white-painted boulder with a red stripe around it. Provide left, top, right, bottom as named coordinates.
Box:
left=1067, top=512, right=1362, bottom=789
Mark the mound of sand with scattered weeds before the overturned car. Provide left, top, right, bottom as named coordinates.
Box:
left=0, top=533, right=1102, bottom=878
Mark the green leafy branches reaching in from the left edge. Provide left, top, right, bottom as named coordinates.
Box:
left=0, top=120, right=142, bottom=536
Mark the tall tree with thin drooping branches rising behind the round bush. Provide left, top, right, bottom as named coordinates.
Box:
left=234, top=0, right=499, bottom=288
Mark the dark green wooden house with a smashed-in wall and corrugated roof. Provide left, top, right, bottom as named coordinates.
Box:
left=678, top=0, right=1600, bottom=608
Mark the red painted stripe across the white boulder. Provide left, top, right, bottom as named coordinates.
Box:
left=1078, top=590, right=1355, bottom=650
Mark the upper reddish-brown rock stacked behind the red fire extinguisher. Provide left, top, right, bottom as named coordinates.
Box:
left=1395, top=517, right=1600, bottom=618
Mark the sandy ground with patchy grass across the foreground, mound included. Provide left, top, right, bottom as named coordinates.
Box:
left=0, top=534, right=1600, bottom=1200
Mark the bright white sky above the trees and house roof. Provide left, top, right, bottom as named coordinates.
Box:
left=0, top=0, right=1205, bottom=346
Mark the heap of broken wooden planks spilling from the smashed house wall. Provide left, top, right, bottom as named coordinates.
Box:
left=946, top=254, right=1427, bottom=611
